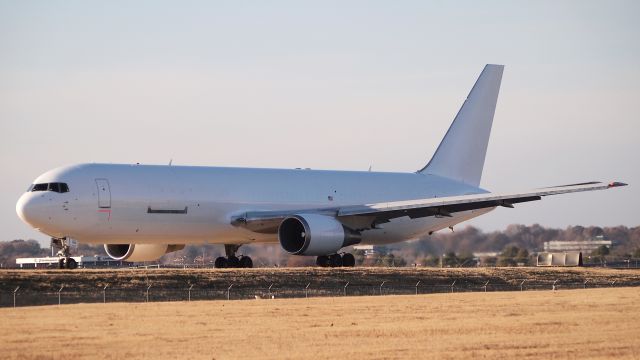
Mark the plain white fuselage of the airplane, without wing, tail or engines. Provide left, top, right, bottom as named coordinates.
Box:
left=16, top=164, right=493, bottom=244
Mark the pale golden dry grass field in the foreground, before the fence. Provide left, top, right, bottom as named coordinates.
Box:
left=0, top=288, right=640, bottom=359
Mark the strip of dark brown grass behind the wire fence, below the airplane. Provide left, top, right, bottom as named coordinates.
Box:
left=5, top=267, right=640, bottom=292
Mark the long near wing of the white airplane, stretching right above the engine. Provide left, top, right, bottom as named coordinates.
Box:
left=231, top=182, right=627, bottom=233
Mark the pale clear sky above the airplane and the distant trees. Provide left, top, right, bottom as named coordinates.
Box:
left=0, top=0, right=640, bottom=246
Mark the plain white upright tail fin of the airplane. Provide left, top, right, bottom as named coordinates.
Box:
left=418, top=64, right=504, bottom=186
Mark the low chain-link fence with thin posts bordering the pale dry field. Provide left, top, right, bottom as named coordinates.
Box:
left=0, top=280, right=629, bottom=307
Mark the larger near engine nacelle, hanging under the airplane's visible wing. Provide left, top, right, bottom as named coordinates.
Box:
left=278, top=214, right=361, bottom=256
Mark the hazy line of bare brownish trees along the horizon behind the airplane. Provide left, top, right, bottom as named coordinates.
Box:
left=0, top=224, right=640, bottom=267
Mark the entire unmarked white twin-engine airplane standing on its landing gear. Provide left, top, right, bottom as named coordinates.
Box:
left=16, top=65, right=626, bottom=268
